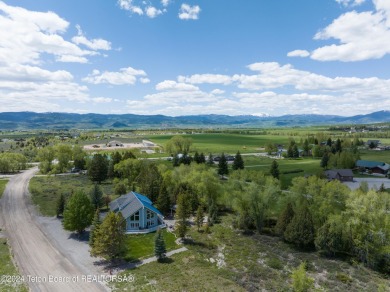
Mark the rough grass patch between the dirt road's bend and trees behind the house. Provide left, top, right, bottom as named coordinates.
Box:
left=29, top=175, right=115, bottom=216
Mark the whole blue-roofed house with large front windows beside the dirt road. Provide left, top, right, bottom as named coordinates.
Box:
left=109, top=192, right=166, bottom=233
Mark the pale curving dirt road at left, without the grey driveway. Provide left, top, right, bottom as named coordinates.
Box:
left=0, top=168, right=108, bottom=292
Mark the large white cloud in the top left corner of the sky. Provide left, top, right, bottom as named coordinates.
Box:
left=0, top=1, right=108, bottom=64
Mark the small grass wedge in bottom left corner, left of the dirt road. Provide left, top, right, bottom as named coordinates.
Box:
left=0, top=238, right=28, bottom=292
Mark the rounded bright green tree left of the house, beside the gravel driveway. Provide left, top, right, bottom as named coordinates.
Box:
left=62, top=192, right=94, bottom=234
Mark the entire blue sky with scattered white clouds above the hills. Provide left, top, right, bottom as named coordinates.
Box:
left=0, top=0, right=390, bottom=116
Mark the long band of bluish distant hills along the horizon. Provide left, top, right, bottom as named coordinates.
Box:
left=0, top=111, right=390, bottom=130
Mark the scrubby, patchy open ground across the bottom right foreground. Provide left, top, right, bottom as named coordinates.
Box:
left=113, top=215, right=390, bottom=291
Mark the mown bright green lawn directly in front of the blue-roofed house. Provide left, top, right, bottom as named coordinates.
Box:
left=125, top=229, right=179, bottom=262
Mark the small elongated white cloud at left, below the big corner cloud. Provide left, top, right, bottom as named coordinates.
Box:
left=83, top=67, right=147, bottom=85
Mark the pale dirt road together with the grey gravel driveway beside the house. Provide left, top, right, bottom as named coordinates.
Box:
left=0, top=167, right=108, bottom=292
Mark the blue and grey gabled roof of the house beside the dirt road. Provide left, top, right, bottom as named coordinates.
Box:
left=109, top=192, right=162, bottom=218
